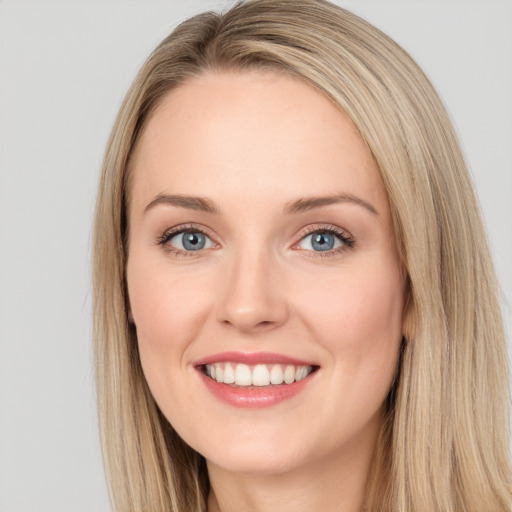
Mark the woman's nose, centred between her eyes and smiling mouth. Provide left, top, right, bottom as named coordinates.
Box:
left=217, top=246, right=288, bottom=333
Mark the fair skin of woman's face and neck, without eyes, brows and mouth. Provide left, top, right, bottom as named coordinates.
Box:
left=127, top=72, right=404, bottom=512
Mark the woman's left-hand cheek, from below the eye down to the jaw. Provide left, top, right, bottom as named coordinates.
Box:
left=126, top=258, right=214, bottom=421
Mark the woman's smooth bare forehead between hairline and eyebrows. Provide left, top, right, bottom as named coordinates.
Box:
left=128, top=72, right=386, bottom=215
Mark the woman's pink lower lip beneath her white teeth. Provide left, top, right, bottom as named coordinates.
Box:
left=198, top=370, right=312, bottom=409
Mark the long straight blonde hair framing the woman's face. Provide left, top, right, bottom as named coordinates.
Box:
left=93, top=0, right=512, bottom=512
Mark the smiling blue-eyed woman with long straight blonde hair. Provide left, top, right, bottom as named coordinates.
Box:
left=94, top=0, right=511, bottom=512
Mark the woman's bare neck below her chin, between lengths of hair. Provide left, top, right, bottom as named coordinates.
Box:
left=208, top=414, right=379, bottom=512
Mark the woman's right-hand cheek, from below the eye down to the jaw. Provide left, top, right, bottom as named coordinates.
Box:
left=292, top=260, right=403, bottom=439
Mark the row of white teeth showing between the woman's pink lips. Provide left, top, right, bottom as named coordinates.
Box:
left=202, top=362, right=318, bottom=388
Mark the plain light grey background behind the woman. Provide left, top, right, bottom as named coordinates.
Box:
left=0, top=0, right=512, bottom=512
